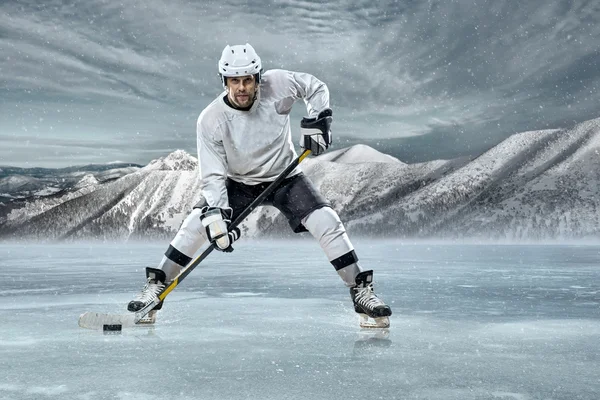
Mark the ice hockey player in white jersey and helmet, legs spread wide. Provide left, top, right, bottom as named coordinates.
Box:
left=127, top=44, right=392, bottom=327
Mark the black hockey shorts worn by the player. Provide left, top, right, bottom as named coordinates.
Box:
left=194, top=173, right=331, bottom=233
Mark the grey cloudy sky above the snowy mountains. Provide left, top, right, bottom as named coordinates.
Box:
left=0, top=0, right=600, bottom=167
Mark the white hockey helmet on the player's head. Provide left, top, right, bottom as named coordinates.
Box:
left=219, top=43, right=262, bottom=86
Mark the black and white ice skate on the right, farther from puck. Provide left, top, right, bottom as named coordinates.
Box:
left=350, top=270, right=392, bottom=328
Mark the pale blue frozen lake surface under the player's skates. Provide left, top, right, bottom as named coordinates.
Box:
left=0, top=239, right=600, bottom=400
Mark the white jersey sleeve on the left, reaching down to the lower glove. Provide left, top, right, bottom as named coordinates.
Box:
left=196, top=113, right=229, bottom=208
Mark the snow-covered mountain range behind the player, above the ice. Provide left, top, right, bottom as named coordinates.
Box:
left=0, top=119, right=600, bottom=239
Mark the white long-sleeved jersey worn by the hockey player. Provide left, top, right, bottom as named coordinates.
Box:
left=196, top=70, right=329, bottom=208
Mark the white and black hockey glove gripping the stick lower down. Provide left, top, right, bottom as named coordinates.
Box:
left=200, top=207, right=240, bottom=253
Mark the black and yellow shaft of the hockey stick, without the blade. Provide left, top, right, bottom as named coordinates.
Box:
left=129, top=149, right=311, bottom=324
